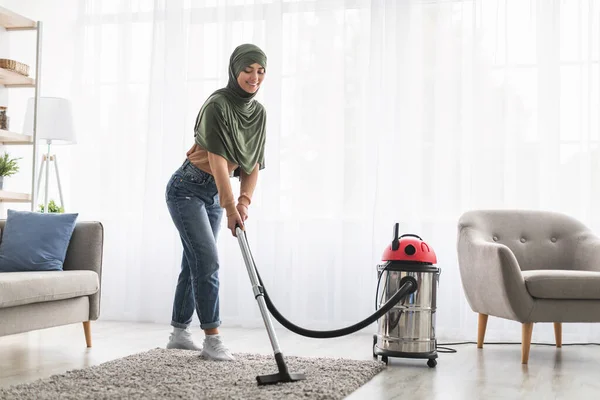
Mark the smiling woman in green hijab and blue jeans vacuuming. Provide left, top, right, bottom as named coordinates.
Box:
left=166, top=44, right=267, bottom=361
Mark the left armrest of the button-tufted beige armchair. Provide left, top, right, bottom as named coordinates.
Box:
left=458, top=227, right=534, bottom=322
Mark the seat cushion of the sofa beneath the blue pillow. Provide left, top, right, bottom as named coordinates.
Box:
left=0, top=271, right=100, bottom=308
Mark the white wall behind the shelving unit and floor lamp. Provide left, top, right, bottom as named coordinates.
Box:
left=0, top=0, right=78, bottom=216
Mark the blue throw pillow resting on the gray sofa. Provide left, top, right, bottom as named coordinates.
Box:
left=0, top=210, right=79, bottom=272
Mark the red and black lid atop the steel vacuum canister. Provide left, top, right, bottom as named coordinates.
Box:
left=382, top=224, right=437, bottom=264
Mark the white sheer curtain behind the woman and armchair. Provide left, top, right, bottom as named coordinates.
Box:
left=71, top=0, right=600, bottom=341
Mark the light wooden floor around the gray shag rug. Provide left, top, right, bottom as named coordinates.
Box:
left=0, top=321, right=600, bottom=400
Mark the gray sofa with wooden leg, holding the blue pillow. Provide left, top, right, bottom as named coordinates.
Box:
left=0, top=220, right=104, bottom=347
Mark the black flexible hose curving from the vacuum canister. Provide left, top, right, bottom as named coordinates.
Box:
left=244, top=232, right=418, bottom=339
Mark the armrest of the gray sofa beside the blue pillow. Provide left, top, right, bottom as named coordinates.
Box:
left=63, top=221, right=104, bottom=321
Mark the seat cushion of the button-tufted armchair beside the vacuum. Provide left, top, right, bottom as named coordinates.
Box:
left=522, top=270, right=600, bottom=300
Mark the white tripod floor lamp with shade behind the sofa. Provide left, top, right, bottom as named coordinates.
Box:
left=23, top=97, right=76, bottom=212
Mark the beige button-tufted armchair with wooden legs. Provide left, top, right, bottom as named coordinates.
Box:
left=457, top=210, right=600, bottom=364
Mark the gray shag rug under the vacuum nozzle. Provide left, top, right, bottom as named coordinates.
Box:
left=0, top=348, right=385, bottom=400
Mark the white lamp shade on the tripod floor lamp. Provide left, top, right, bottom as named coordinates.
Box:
left=23, top=97, right=76, bottom=144
